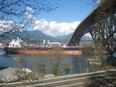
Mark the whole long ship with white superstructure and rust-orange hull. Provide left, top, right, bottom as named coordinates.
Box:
left=4, top=38, right=82, bottom=55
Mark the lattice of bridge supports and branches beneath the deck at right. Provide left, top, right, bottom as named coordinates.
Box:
left=90, top=14, right=116, bottom=52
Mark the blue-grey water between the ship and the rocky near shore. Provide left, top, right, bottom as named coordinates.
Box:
left=0, top=50, right=89, bottom=75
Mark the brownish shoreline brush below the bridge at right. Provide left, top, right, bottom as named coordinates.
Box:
left=77, top=42, right=114, bottom=73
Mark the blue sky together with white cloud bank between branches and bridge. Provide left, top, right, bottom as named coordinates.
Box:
left=33, top=0, right=94, bottom=36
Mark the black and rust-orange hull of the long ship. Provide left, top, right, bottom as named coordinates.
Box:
left=4, top=46, right=82, bottom=55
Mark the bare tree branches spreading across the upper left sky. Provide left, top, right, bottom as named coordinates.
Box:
left=0, top=0, right=57, bottom=37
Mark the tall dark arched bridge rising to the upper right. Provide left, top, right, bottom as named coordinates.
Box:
left=68, top=0, right=116, bottom=56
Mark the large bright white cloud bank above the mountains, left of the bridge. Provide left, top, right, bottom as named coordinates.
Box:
left=34, top=19, right=80, bottom=36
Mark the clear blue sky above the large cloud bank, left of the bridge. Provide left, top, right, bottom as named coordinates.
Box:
left=38, top=0, right=93, bottom=22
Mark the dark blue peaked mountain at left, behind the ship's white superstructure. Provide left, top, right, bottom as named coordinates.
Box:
left=5, top=30, right=57, bottom=41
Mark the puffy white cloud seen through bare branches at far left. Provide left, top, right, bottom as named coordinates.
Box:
left=0, top=6, right=36, bottom=33
